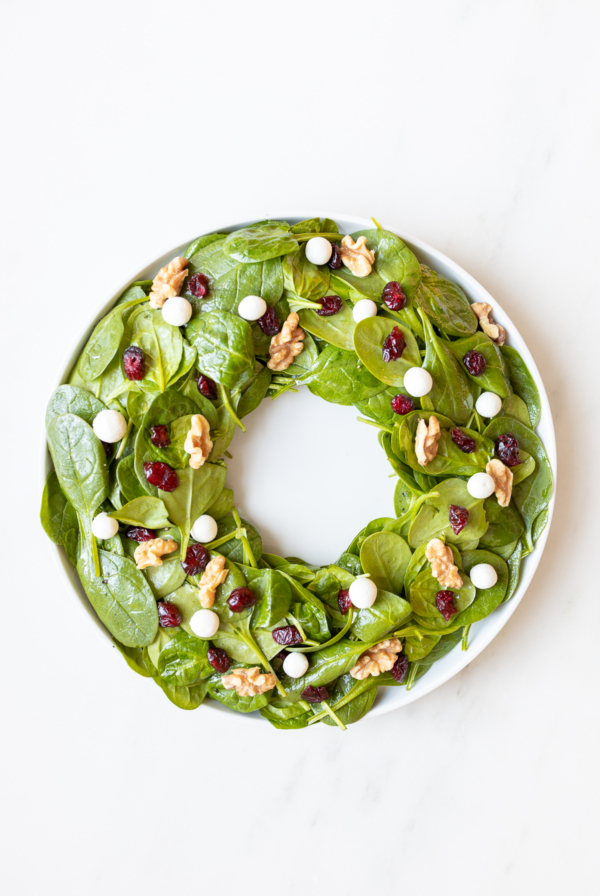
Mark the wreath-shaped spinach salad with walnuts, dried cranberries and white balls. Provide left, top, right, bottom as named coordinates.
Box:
left=41, top=218, right=552, bottom=728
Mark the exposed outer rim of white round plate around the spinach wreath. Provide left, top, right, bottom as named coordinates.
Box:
left=41, top=211, right=556, bottom=721
